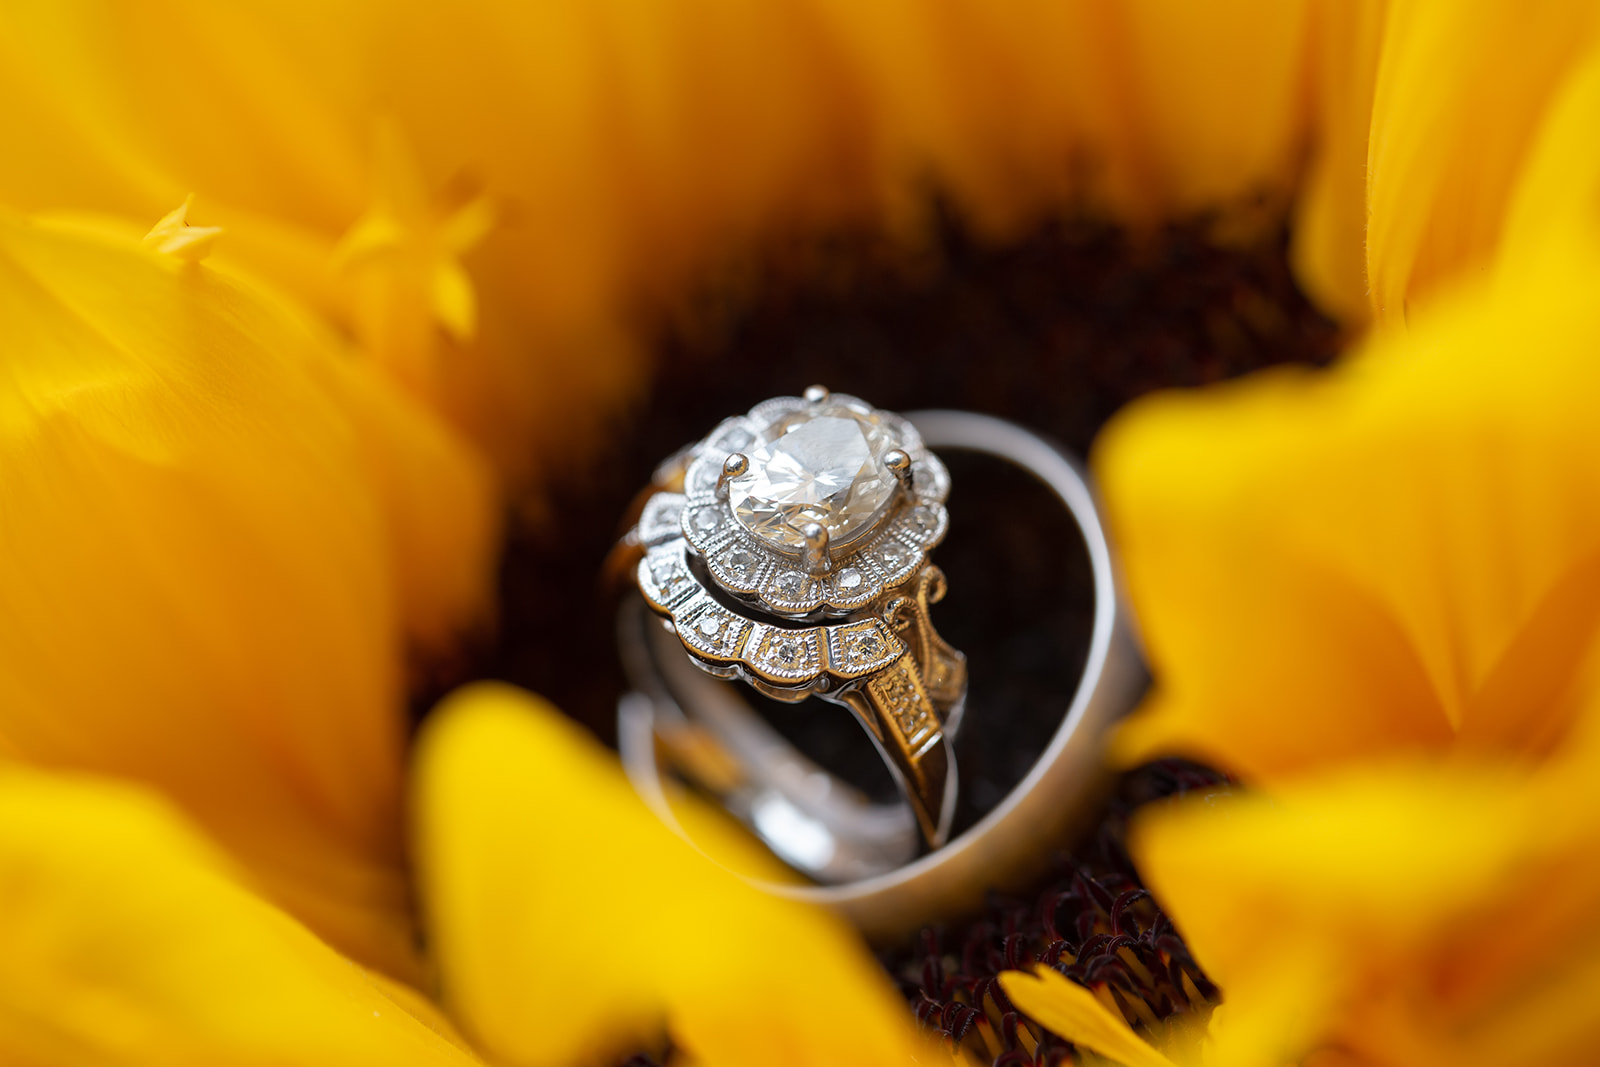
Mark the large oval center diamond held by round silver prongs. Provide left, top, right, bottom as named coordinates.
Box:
left=728, top=403, right=899, bottom=549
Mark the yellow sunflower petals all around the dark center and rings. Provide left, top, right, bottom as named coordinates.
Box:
left=0, top=0, right=1600, bottom=1064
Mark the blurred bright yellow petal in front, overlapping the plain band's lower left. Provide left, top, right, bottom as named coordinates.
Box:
left=414, top=685, right=920, bottom=1067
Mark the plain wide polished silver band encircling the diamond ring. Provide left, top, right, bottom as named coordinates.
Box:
left=618, top=411, right=1147, bottom=937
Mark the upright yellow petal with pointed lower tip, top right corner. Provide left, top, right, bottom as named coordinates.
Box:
left=1366, top=0, right=1600, bottom=323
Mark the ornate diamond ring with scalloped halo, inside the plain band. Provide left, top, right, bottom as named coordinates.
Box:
left=629, top=386, right=966, bottom=857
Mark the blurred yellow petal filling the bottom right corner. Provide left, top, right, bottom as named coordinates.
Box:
left=1130, top=753, right=1600, bottom=1067
